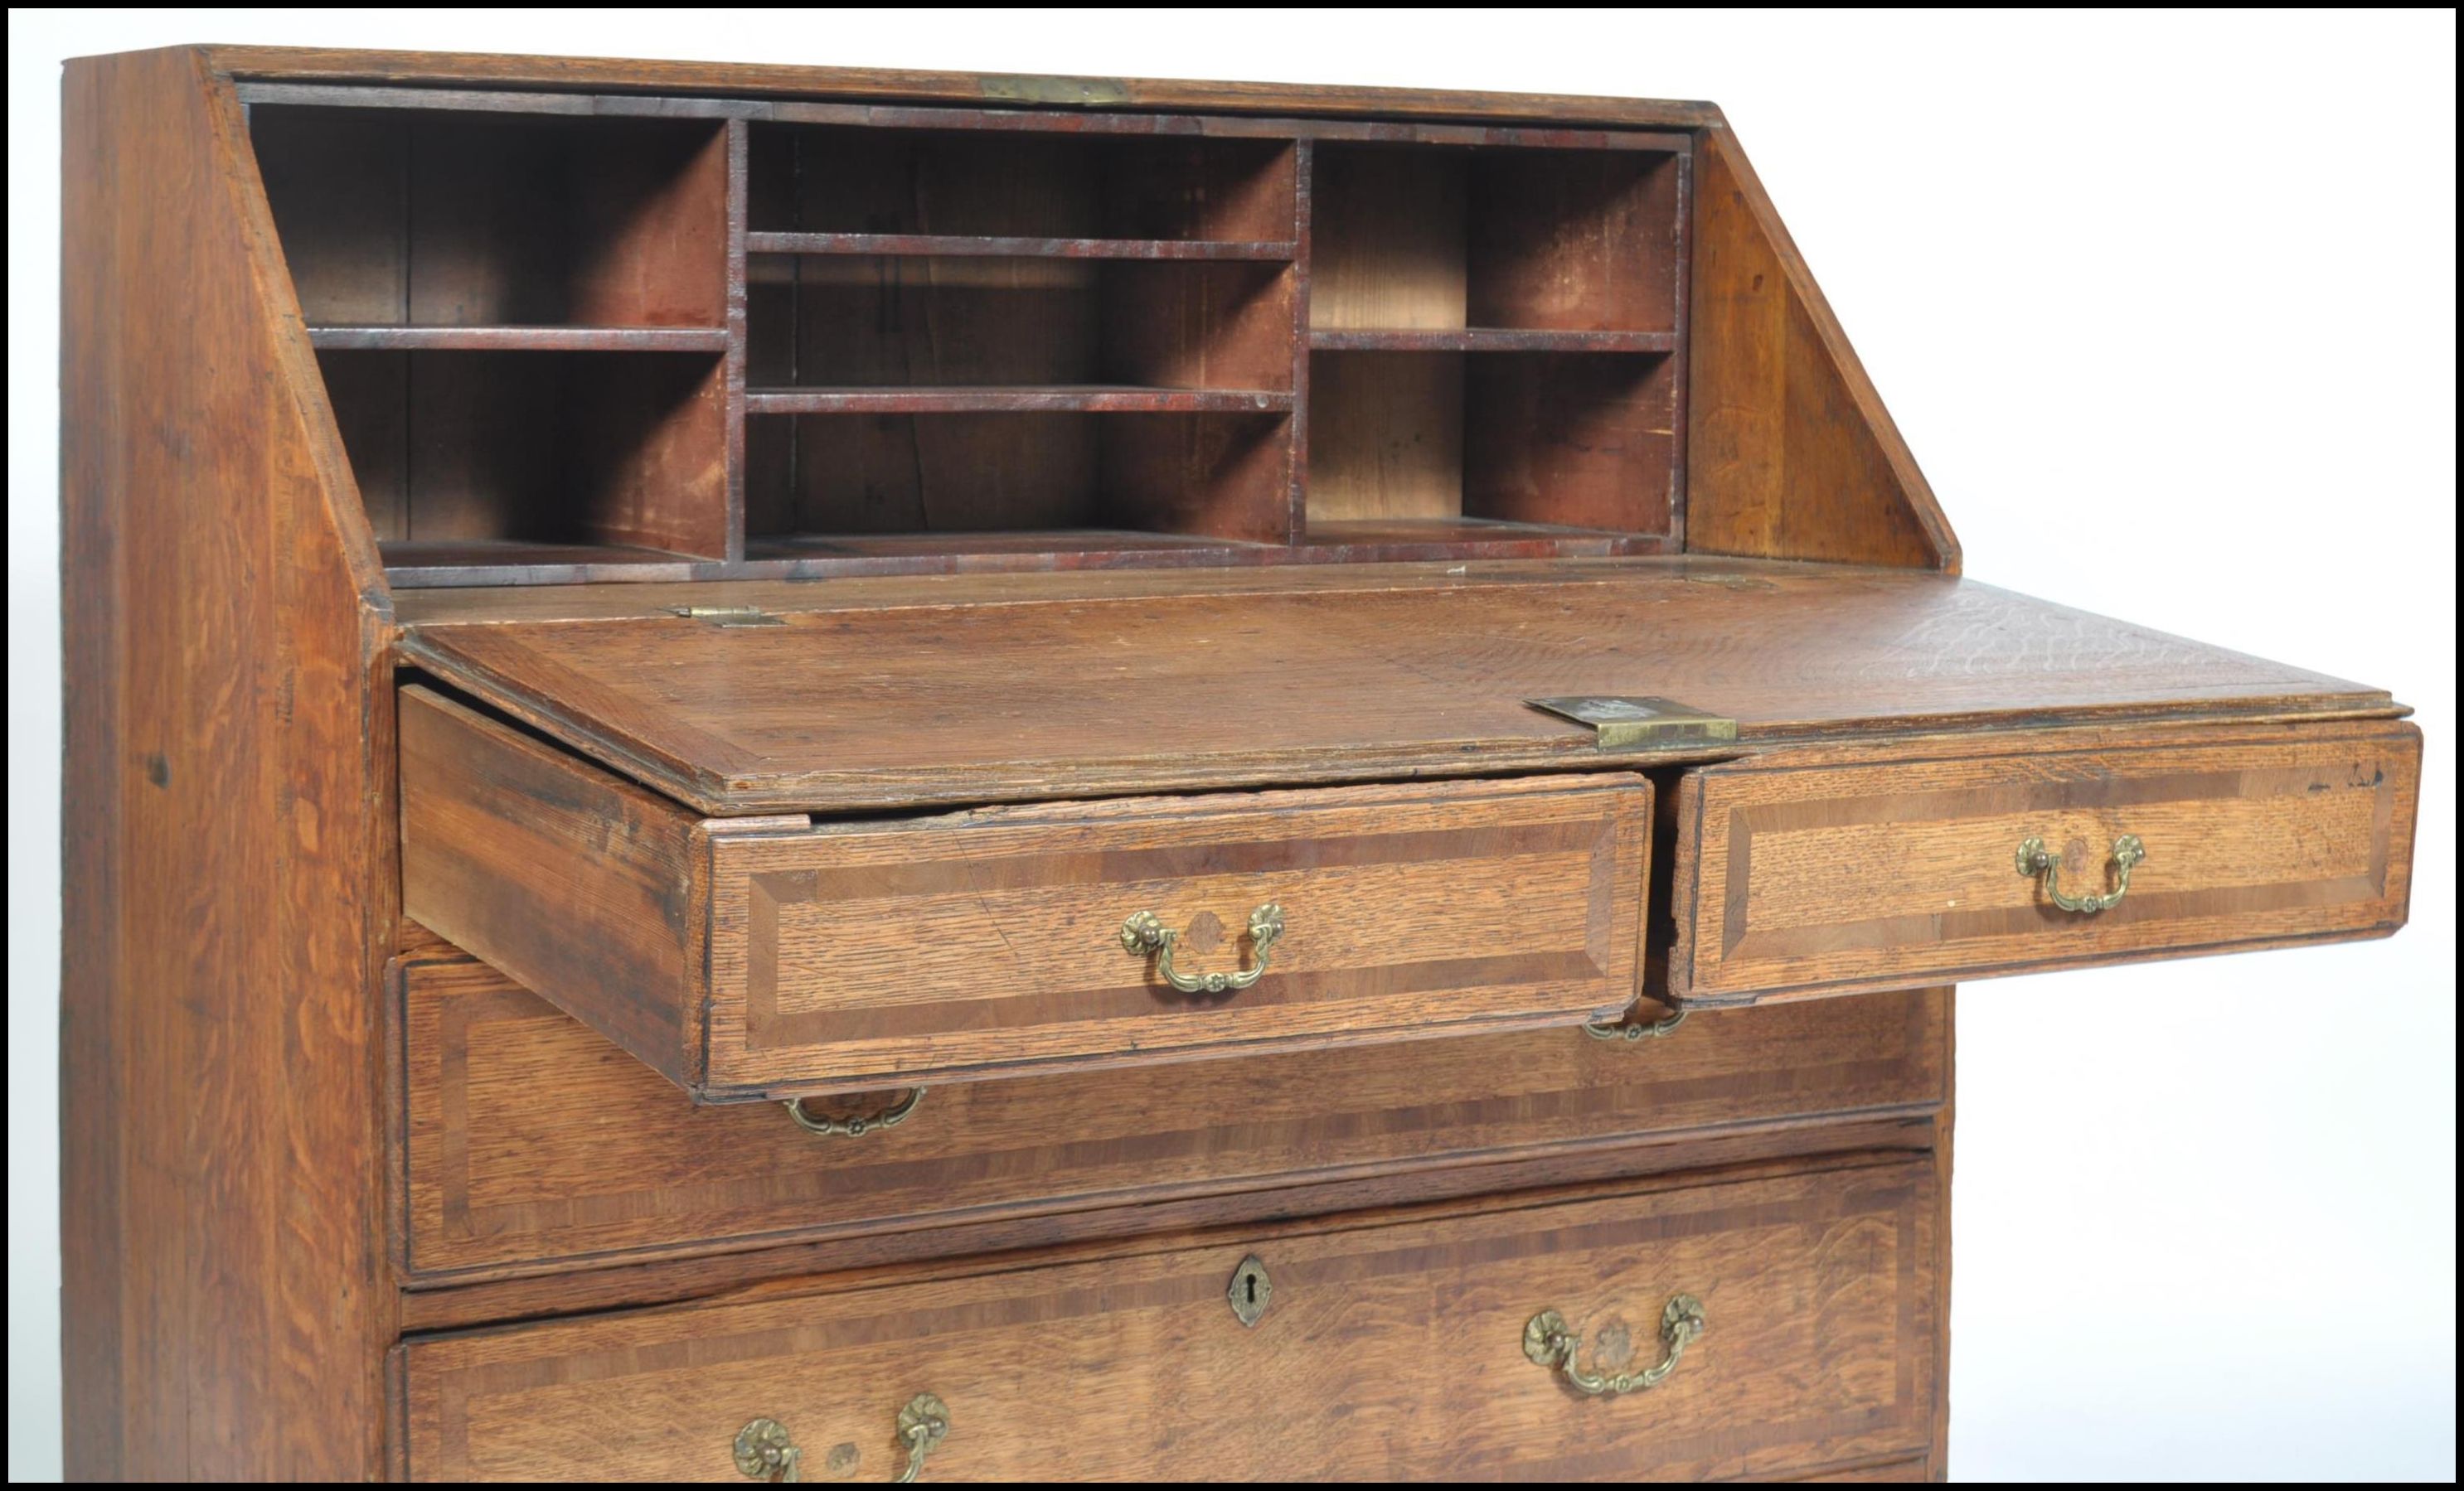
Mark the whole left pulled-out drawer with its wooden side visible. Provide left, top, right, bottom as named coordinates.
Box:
left=401, top=688, right=1651, bottom=1101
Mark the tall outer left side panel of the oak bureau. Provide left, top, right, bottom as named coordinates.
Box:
left=61, top=49, right=395, bottom=1481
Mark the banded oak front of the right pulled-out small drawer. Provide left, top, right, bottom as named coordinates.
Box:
left=1668, top=724, right=2422, bottom=1003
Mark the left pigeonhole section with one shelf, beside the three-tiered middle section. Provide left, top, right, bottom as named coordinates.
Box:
left=251, top=104, right=730, bottom=574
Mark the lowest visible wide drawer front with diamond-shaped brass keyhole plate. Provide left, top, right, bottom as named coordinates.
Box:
left=401, top=1161, right=1939, bottom=1481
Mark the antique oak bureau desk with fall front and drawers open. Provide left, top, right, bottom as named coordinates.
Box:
left=64, top=46, right=2420, bottom=1484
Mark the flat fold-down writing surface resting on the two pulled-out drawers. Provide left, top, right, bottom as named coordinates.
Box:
left=406, top=562, right=2393, bottom=813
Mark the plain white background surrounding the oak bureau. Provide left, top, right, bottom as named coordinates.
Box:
left=7, top=10, right=2457, bottom=1479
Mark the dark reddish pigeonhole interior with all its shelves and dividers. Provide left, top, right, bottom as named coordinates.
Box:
left=251, top=89, right=1690, bottom=584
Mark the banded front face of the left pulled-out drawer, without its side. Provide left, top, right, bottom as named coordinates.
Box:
left=705, top=777, right=1651, bottom=1096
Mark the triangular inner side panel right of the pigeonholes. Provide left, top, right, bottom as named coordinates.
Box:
left=1686, top=128, right=1959, bottom=574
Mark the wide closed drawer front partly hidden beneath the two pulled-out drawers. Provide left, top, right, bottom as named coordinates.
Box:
left=401, top=961, right=1949, bottom=1279
